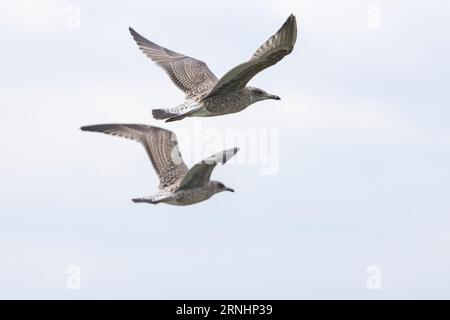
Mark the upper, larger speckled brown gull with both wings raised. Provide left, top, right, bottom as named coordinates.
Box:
left=129, top=14, right=297, bottom=122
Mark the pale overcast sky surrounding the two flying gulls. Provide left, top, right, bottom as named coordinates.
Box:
left=0, top=0, right=450, bottom=299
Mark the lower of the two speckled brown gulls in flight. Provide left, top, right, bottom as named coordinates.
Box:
left=81, top=124, right=239, bottom=206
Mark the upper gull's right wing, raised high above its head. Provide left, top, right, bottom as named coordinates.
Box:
left=205, top=14, right=297, bottom=98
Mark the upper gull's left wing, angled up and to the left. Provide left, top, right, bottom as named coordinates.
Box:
left=129, top=27, right=218, bottom=99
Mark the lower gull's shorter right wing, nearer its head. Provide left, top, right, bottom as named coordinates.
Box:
left=179, top=148, right=239, bottom=189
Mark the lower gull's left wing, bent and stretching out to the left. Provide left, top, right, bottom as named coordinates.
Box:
left=81, top=124, right=188, bottom=189
